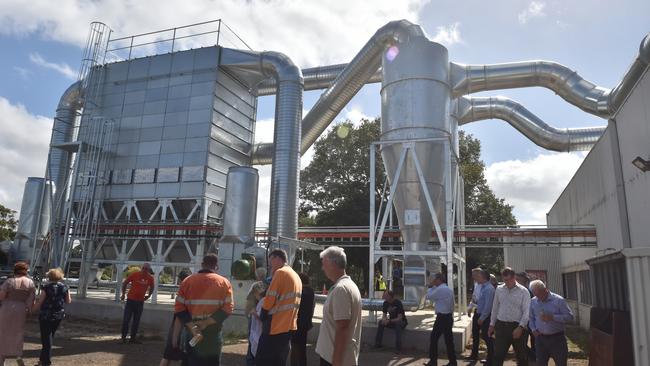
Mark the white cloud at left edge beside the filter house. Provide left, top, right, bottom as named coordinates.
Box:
left=0, top=97, right=52, bottom=211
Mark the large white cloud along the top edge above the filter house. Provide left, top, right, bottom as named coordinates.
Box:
left=0, top=0, right=429, bottom=67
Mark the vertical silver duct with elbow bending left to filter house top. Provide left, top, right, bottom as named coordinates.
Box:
left=221, top=48, right=303, bottom=239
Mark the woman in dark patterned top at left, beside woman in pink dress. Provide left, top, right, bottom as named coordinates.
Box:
left=33, top=268, right=72, bottom=366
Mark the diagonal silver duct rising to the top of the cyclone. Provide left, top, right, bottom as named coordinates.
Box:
left=253, top=20, right=424, bottom=164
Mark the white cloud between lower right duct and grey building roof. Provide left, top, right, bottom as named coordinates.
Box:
left=485, top=152, right=585, bottom=225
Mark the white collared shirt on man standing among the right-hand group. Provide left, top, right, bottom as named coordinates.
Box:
left=490, top=283, right=530, bottom=328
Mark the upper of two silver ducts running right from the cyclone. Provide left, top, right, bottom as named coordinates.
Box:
left=451, top=34, right=650, bottom=118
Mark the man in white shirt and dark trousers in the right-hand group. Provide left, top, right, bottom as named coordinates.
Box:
left=488, top=267, right=530, bottom=366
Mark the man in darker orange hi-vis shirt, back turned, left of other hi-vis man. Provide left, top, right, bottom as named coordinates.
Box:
left=174, top=254, right=234, bottom=366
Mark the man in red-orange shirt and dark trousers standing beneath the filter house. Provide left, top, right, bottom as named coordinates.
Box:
left=121, top=263, right=154, bottom=344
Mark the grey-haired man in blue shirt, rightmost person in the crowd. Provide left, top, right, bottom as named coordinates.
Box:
left=529, top=280, right=574, bottom=366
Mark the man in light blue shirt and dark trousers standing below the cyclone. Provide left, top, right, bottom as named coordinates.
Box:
left=426, top=273, right=457, bottom=366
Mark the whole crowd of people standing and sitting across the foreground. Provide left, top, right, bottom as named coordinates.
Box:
left=0, top=252, right=573, bottom=366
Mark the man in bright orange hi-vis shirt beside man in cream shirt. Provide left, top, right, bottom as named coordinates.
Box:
left=255, top=249, right=302, bottom=366
